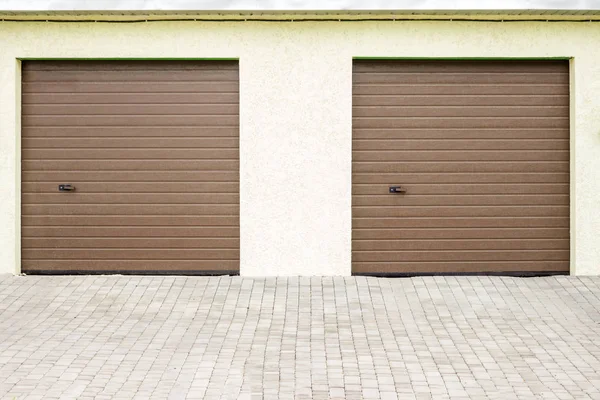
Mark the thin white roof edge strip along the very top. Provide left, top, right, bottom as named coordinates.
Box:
left=0, top=0, right=600, bottom=14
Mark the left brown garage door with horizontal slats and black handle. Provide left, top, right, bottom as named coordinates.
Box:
left=22, top=61, right=239, bottom=274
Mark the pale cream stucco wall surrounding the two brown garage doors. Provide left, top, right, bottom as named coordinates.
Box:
left=0, top=21, right=600, bottom=275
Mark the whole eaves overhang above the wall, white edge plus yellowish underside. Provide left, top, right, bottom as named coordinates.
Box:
left=0, top=0, right=600, bottom=21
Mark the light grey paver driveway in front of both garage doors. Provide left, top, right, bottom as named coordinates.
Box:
left=0, top=276, right=600, bottom=399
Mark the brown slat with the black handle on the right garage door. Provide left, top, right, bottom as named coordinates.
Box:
left=352, top=184, right=568, bottom=197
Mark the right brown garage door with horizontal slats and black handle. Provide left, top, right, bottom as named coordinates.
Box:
left=352, top=61, right=569, bottom=274
